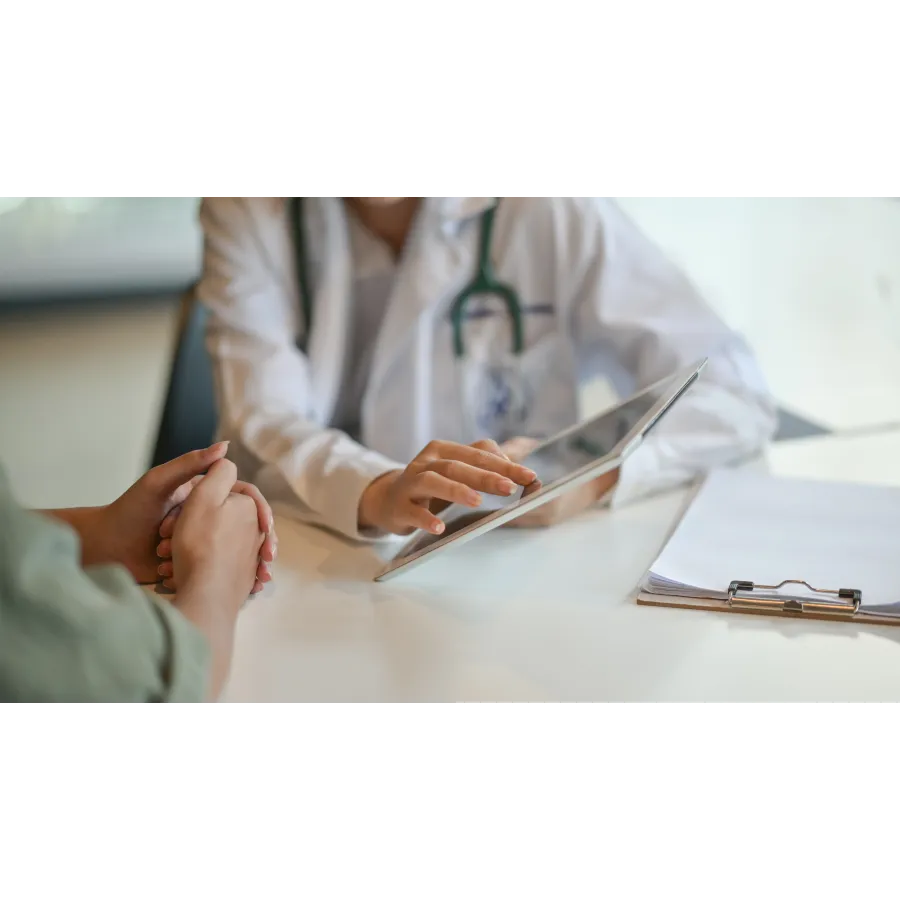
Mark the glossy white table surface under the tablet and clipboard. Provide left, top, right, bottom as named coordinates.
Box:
left=225, top=433, right=900, bottom=703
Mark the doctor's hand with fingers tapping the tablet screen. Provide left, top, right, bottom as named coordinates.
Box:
left=359, top=441, right=537, bottom=535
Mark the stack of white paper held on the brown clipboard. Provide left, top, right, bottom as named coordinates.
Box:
left=642, top=470, right=900, bottom=616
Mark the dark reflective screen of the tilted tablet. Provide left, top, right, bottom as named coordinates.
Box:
left=397, top=364, right=690, bottom=561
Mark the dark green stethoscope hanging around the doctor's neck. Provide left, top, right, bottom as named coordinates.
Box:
left=290, top=194, right=529, bottom=433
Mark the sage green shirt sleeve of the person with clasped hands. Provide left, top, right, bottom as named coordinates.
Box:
left=0, top=469, right=210, bottom=703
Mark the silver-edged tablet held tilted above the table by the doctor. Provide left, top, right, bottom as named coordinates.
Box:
left=375, top=360, right=706, bottom=581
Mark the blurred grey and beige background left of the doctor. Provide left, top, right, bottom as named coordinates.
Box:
left=0, top=194, right=201, bottom=507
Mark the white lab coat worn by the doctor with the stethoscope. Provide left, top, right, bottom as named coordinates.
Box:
left=198, top=193, right=776, bottom=539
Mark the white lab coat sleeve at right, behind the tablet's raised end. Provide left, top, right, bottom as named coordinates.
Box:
left=571, top=196, right=777, bottom=507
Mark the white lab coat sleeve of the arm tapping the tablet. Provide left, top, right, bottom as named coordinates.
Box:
left=198, top=195, right=403, bottom=540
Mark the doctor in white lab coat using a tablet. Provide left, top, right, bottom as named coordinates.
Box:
left=198, top=193, right=776, bottom=539
